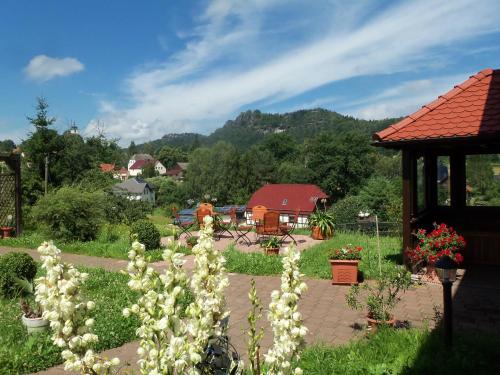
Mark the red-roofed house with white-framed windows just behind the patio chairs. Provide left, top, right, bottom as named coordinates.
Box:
left=245, top=184, right=328, bottom=228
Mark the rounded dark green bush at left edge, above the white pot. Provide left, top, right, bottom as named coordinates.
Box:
left=0, top=252, right=36, bottom=297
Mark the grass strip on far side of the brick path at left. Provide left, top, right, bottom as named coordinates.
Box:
left=0, top=225, right=162, bottom=262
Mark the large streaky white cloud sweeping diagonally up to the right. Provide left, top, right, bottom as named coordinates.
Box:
left=87, top=0, right=500, bottom=142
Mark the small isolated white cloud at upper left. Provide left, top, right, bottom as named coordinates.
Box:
left=24, top=55, right=85, bottom=82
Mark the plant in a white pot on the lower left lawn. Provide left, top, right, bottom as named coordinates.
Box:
left=14, top=277, right=49, bottom=333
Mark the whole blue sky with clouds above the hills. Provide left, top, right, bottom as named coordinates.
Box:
left=0, top=0, right=500, bottom=146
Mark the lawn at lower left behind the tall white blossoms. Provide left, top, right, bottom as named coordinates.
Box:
left=0, top=267, right=193, bottom=375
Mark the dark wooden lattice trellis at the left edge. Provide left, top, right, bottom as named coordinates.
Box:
left=0, top=153, right=22, bottom=235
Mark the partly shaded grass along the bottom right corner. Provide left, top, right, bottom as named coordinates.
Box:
left=299, top=329, right=500, bottom=375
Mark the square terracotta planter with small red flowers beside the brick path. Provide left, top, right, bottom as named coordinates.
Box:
left=330, top=244, right=363, bottom=285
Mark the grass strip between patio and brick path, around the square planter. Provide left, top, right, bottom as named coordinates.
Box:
left=224, top=232, right=402, bottom=279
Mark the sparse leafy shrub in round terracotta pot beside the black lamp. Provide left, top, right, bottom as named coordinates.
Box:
left=346, top=267, right=411, bottom=332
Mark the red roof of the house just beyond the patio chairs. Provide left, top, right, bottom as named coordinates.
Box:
left=247, top=184, right=328, bottom=213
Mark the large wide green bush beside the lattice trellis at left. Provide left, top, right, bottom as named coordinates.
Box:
left=33, top=187, right=104, bottom=241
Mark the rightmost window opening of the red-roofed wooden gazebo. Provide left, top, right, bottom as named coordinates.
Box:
left=465, top=154, right=500, bottom=206
